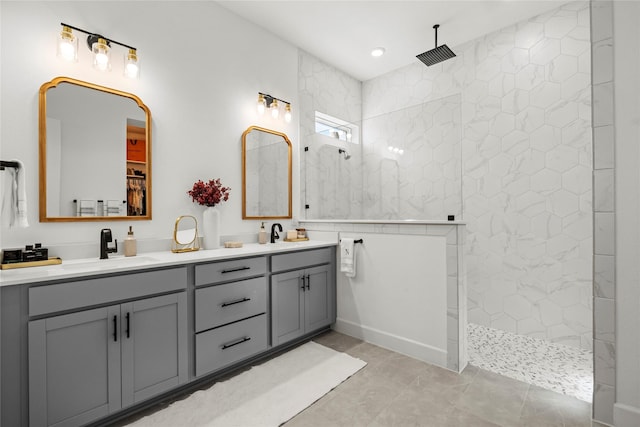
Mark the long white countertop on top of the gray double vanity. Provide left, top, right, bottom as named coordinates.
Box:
left=0, top=240, right=337, bottom=287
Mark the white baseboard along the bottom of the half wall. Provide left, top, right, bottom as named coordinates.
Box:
left=333, top=318, right=447, bottom=368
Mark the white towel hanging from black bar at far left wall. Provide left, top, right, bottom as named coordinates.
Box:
left=1, top=160, right=29, bottom=228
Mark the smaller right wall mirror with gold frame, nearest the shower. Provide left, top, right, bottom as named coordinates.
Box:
left=242, top=126, right=292, bottom=219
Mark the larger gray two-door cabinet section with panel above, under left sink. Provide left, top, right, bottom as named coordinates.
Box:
left=28, top=269, right=188, bottom=427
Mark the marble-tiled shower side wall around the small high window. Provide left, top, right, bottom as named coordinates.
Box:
left=298, top=51, right=363, bottom=219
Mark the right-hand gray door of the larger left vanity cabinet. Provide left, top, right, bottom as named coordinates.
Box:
left=120, top=292, right=188, bottom=407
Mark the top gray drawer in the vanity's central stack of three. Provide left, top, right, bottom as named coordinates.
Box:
left=196, top=256, right=267, bottom=286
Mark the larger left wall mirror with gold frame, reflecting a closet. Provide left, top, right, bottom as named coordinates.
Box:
left=39, top=77, right=151, bottom=222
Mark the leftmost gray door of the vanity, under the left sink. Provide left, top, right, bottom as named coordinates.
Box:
left=29, top=306, right=121, bottom=427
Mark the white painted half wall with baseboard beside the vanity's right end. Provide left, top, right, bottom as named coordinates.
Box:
left=335, top=233, right=447, bottom=367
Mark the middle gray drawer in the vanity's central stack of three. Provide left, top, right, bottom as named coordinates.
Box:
left=196, top=277, right=267, bottom=332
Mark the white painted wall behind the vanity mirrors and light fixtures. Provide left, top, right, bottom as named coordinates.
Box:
left=0, top=1, right=299, bottom=248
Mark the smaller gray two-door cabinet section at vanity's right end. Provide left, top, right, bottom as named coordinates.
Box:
left=271, top=248, right=336, bottom=346
